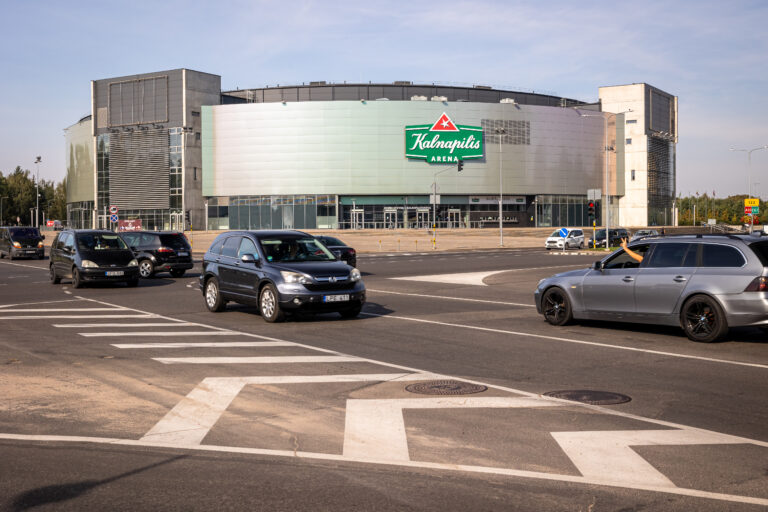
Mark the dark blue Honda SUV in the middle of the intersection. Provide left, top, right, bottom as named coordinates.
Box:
left=200, top=231, right=365, bottom=322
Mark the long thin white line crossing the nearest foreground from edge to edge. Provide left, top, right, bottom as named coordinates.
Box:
left=0, top=434, right=768, bottom=506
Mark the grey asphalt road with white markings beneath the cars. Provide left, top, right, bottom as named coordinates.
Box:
left=0, top=250, right=768, bottom=511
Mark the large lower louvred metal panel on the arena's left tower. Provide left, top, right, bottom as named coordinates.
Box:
left=109, top=130, right=169, bottom=210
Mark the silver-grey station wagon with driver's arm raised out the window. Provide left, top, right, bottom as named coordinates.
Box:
left=534, top=235, right=768, bottom=342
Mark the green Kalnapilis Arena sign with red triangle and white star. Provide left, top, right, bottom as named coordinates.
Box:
left=405, top=112, right=483, bottom=163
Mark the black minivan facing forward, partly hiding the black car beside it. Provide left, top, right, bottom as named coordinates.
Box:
left=49, top=229, right=139, bottom=288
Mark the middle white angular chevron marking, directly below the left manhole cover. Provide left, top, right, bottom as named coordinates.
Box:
left=344, top=396, right=567, bottom=460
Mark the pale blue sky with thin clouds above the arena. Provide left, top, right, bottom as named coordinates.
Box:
left=0, top=0, right=768, bottom=197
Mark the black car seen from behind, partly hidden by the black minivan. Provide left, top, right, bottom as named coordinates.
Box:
left=120, top=231, right=194, bottom=278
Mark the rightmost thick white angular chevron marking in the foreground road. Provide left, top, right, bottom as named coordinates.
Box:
left=551, top=430, right=741, bottom=487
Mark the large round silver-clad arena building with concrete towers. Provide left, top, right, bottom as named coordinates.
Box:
left=66, top=69, right=677, bottom=229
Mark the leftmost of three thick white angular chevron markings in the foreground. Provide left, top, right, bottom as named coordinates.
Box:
left=141, top=373, right=429, bottom=446
